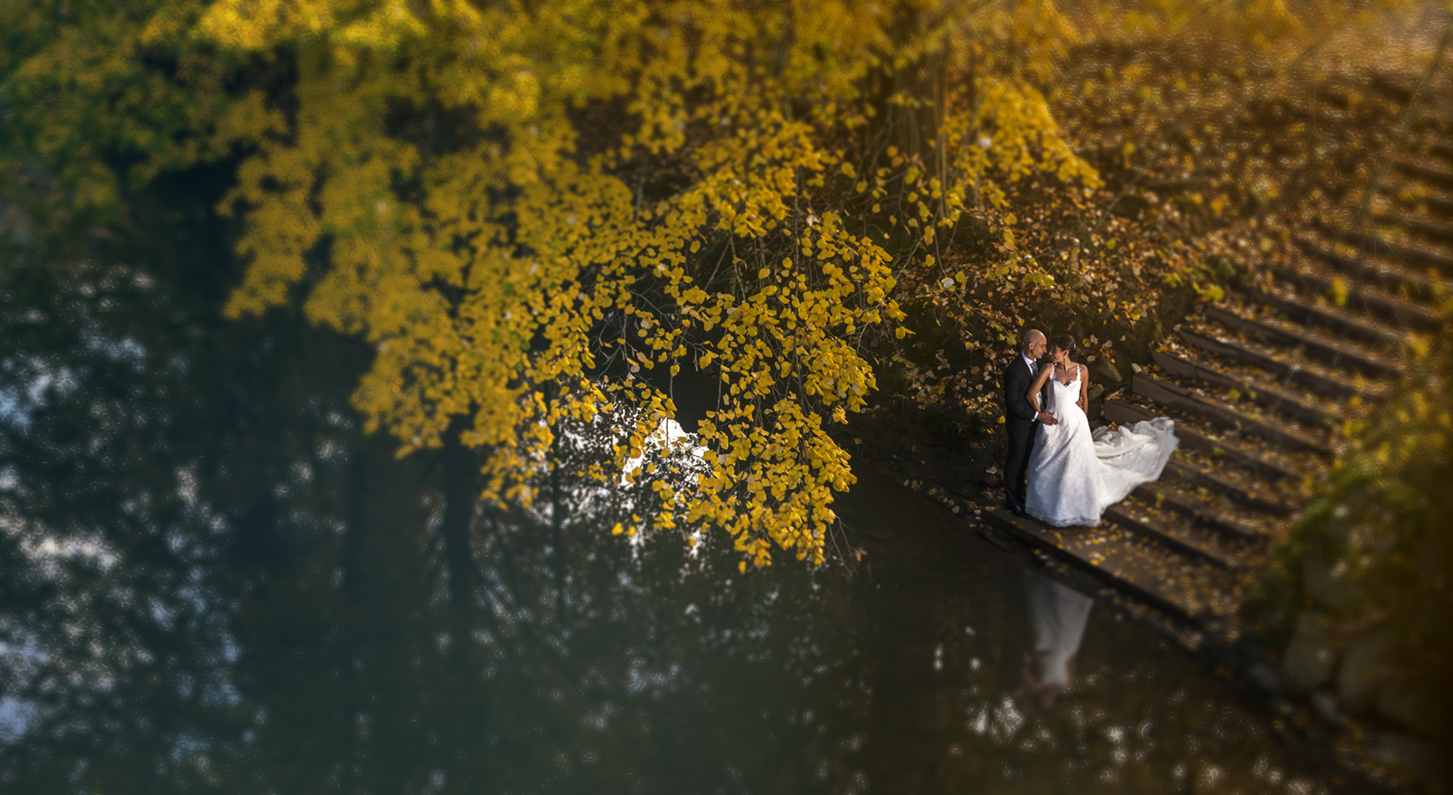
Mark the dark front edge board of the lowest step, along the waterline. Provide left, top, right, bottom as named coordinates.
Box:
left=984, top=509, right=1206, bottom=625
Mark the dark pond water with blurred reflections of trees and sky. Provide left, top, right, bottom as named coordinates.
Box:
left=0, top=177, right=1336, bottom=795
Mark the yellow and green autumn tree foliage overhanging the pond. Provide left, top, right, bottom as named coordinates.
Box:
left=0, top=0, right=1418, bottom=565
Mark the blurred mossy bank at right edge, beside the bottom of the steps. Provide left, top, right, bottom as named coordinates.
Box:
left=1250, top=342, right=1453, bottom=782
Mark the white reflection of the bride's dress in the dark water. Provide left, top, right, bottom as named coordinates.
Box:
left=1024, top=568, right=1091, bottom=709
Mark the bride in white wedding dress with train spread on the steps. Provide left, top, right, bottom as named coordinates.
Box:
left=1024, top=334, right=1178, bottom=528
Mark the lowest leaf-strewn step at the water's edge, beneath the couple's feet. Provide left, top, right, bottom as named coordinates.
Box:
left=984, top=509, right=1239, bottom=628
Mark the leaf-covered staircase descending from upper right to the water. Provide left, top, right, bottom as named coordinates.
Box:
left=984, top=76, right=1453, bottom=648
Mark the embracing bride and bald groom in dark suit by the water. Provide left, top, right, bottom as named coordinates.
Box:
left=1001, top=328, right=1178, bottom=528
